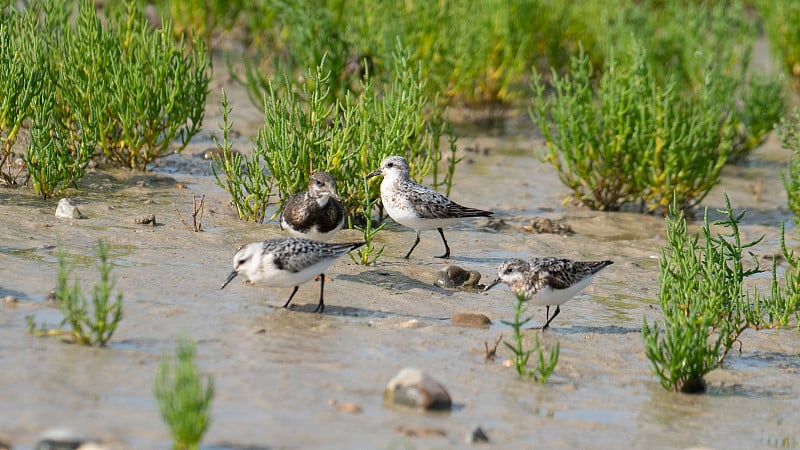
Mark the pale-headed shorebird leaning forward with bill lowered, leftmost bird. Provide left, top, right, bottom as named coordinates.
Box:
left=220, top=238, right=364, bottom=313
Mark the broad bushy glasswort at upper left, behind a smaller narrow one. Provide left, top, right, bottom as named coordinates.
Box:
left=51, top=0, right=211, bottom=170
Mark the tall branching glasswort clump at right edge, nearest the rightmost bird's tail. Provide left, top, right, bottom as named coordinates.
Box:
left=642, top=195, right=800, bottom=392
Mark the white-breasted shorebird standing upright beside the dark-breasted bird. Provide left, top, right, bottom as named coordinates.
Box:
left=367, top=156, right=492, bottom=259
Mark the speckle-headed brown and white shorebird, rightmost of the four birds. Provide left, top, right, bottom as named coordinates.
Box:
left=484, top=258, right=614, bottom=330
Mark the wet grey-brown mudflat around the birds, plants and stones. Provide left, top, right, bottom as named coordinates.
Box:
left=0, top=81, right=800, bottom=449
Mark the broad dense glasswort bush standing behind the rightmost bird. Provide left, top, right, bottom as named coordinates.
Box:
left=529, top=44, right=731, bottom=214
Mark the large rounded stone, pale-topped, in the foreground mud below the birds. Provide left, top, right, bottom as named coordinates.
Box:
left=383, top=368, right=453, bottom=411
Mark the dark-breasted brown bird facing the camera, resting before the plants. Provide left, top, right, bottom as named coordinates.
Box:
left=280, top=171, right=344, bottom=241
